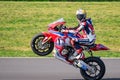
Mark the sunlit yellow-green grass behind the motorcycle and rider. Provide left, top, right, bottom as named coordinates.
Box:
left=0, top=1, right=120, bottom=57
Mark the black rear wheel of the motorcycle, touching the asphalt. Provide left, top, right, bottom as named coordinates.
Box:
left=80, top=57, right=106, bottom=80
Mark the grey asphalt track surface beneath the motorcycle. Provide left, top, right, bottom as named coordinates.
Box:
left=0, top=58, right=120, bottom=80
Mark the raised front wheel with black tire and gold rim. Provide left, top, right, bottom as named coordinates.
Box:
left=31, top=33, right=54, bottom=56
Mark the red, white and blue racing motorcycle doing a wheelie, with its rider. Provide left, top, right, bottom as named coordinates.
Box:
left=31, top=9, right=109, bottom=80
